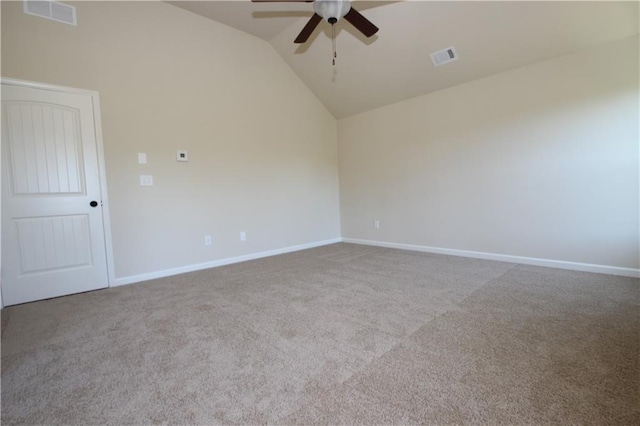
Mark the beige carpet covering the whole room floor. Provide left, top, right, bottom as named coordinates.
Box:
left=1, top=243, right=640, bottom=425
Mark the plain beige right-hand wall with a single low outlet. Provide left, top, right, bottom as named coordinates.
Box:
left=338, top=37, right=640, bottom=269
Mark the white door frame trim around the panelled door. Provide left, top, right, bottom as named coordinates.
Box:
left=0, top=77, right=115, bottom=307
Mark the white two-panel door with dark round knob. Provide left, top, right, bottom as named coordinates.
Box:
left=2, top=83, right=108, bottom=305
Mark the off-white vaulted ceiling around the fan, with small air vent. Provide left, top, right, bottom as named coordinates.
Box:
left=170, top=0, right=640, bottom=118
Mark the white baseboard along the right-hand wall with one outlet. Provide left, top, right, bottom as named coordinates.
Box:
left=342, top=238, right=640, bottom=278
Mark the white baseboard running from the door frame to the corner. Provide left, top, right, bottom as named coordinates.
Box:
left=111, top=238, right=342, bottom=287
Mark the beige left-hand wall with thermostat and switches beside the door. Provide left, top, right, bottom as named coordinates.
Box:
left=2, top=2, right=340, bottom=277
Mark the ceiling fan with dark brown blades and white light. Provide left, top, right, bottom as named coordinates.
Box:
left=251, top=0, right=378, bottom=43
